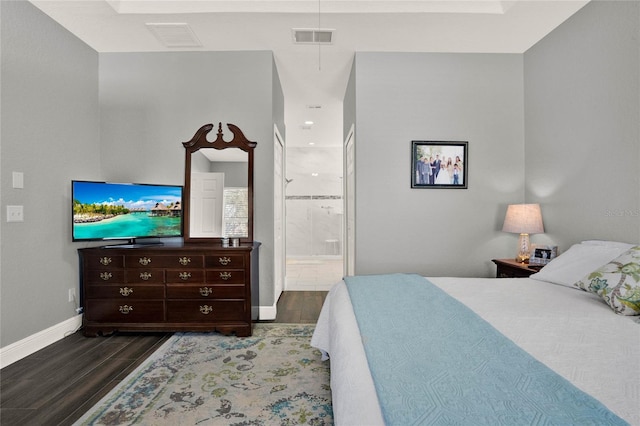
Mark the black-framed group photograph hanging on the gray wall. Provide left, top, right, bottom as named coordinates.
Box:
left=411, top=141, right=469, bottom=189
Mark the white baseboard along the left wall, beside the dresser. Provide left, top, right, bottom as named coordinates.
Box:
left=0, top=314, right=82, bottom=368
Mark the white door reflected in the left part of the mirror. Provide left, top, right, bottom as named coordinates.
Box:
left=189, top=172, right=224, bottom=238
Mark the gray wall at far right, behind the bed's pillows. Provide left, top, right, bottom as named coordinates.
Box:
left=524, top=1, right=640, bottom=250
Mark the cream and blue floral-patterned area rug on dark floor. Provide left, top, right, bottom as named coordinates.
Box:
left=75, top=323, right=333, bottom=426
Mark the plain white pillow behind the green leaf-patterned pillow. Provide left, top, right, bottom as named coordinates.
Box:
left=529, top=243, right=633, bottom=288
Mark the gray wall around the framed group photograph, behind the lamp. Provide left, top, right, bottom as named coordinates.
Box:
left=348, top=53, right=524, bottom=276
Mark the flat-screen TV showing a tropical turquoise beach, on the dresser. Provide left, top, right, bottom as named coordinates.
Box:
left=71, top=180, right=182, bottom=243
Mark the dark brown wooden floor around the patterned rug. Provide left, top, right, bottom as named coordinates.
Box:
left=0, top=291, right=327, bottom=426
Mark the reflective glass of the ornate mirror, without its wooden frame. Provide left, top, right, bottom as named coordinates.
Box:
left=189, top=148, right=249, bottom=238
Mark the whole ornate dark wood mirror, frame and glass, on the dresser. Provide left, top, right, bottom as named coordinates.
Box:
left=182, top=123, right=257, bottom=243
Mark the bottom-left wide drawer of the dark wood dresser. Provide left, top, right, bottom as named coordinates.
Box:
left=85, top=299, right=164, bottom=322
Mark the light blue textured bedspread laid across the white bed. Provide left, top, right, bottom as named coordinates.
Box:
left=345, top=274, right=627, bottom=426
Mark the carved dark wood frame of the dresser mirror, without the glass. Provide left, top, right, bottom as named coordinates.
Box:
left=182, top=123, right=257, bottom=243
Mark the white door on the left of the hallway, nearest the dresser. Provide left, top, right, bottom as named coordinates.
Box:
left=273, top=125, right=286, bottom=304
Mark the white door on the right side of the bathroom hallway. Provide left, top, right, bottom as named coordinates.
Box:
left=344, top=125, right=356, bottom=276
